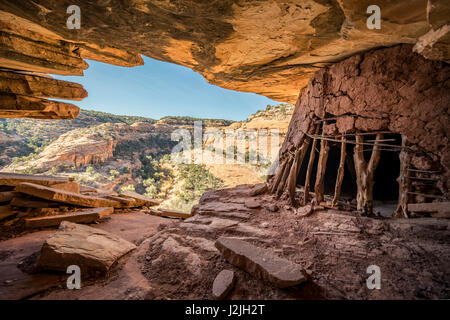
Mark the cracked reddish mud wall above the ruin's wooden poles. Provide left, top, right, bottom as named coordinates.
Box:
left=280, top=45, right=450, bottom=197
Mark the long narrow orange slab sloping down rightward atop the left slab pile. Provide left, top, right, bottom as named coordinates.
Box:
left=16, top=183, right=122, bottom=208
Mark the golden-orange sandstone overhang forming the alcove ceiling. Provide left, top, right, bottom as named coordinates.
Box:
left=0, top=0, right=449, bottom=103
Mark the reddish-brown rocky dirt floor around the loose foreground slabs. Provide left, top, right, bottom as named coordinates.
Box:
left=0, top=186, right=450, bottom=299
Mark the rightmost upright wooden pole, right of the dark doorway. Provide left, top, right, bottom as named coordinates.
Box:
left=392, top=135, right=411, bottom=218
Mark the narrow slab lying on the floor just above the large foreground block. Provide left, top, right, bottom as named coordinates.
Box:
left=25, top=207, right=114, bottom=228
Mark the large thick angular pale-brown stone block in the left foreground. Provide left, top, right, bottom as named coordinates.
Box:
left=38, top=221, right=136, bottom=275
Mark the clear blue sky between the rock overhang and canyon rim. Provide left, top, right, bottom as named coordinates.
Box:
left=55, top=57, right=278, bottom=120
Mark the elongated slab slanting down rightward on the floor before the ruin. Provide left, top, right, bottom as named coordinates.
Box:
left=215, top=237, right=307, bottom=288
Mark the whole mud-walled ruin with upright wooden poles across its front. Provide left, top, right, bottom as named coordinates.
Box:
left=271, top=45, right=450, bottom=218
